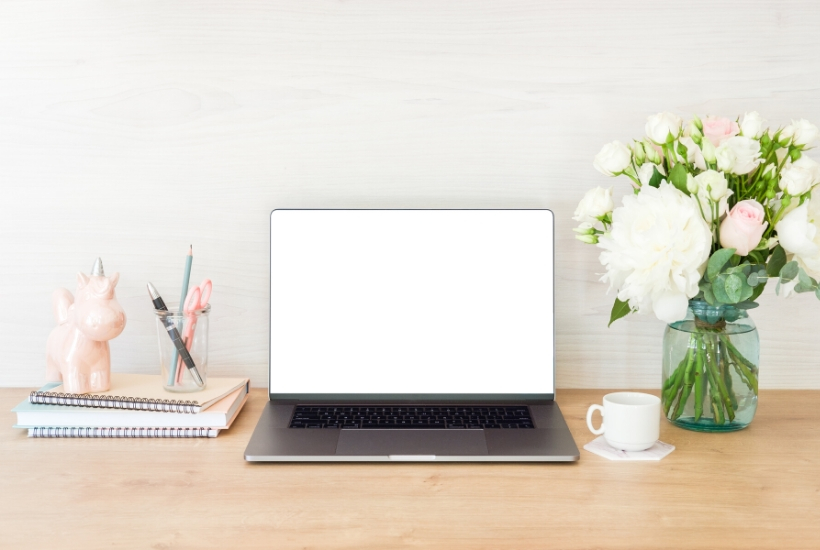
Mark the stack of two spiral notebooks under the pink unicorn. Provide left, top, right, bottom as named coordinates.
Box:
left=12, top=373, right=250, bottom=437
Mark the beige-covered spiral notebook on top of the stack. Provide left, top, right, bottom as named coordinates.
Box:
left=29, top=373, right=249, bottom=413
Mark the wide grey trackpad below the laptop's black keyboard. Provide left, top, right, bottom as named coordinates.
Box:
left=336, top=430, right=487, bottom=457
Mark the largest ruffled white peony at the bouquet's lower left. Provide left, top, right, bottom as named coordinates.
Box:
left=598, top=182, right=712, bottom=323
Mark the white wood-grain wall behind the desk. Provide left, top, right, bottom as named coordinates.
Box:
left=0, top=0, right=820, bottom=391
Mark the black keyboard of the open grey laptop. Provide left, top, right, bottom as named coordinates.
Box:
left=290, top=405, right=533, bottom=430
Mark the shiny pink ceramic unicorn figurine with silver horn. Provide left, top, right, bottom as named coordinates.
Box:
left=46, top=258, right=125, bottom=393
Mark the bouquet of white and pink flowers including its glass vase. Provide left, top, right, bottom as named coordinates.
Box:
left=573, top=112, right=820, bottom=431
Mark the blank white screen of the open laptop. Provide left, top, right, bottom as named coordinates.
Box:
left=269, top=210, right=554, bottom=398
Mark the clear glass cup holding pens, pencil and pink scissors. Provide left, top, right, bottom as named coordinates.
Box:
left=154, top=304, right=211, bottom=393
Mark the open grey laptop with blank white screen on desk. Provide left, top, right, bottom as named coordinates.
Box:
left=245, top=210, right=579, bottom=462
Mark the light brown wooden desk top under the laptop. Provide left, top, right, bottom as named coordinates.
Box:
left=0, top=388, right=820, bottom=550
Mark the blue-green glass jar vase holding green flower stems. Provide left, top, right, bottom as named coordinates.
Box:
left=661, top=300, right=760, bottom=432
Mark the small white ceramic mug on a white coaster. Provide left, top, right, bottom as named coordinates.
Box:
left=587, top=392, right=661, bottom=451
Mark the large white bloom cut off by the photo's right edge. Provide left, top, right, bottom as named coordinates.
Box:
left=774, top=199, right=820, bottom=279
